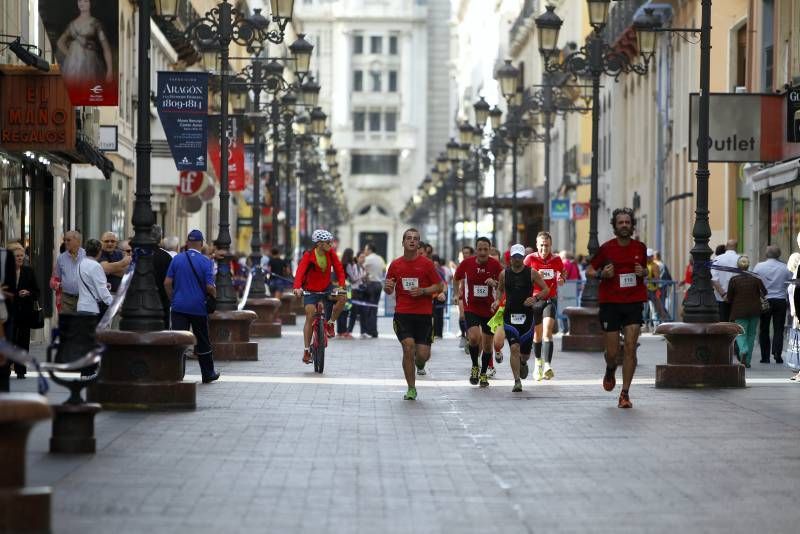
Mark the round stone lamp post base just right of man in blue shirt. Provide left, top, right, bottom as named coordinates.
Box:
left=208, top=310, right=258, bottom=362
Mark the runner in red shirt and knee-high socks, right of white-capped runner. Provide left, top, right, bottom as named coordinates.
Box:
left=524, top=232, right=567, bottom=380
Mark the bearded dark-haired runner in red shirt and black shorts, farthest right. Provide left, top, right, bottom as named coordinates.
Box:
left=586, top=208, right=647, bottom=408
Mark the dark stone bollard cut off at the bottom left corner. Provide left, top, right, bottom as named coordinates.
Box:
left=0, top=393, right=51, bottom=532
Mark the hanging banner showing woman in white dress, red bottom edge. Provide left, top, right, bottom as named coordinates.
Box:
left=39, top=0, right=119, bottom=106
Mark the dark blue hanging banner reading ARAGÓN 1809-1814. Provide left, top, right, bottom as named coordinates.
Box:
left=156, top=71, right=208, bottom=171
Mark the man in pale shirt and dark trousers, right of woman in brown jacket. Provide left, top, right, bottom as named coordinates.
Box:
left=753, top=245, right=792, bottom=363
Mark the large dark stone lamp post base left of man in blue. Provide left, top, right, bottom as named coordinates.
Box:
left=87, top=330, right=197, bottom=410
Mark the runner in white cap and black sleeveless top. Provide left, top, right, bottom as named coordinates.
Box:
left=492, top=244, right=550, bottom=393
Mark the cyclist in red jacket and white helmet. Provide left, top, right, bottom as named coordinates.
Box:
left=294, top=229, right=346, bottom=363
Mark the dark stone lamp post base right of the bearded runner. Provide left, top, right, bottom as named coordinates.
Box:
left=655, top=323, right=745, bottom=388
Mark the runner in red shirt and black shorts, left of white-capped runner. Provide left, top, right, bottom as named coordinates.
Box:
left=453, top=237, right=503, bottom=388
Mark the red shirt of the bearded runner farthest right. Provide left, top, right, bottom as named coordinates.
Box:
left=591, top=238, right=647, bottom=304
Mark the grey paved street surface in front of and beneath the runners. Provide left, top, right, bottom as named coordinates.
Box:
left=12, top=319, right=800, bottom=534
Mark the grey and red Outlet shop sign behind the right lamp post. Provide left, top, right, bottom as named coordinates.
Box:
left=689, top=93, right=783, bottom=162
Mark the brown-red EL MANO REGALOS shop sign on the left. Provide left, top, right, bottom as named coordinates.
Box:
left=0, top=67, right=75, bottom=152
